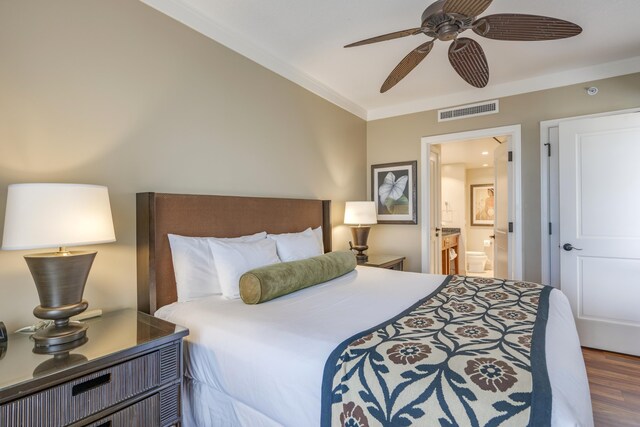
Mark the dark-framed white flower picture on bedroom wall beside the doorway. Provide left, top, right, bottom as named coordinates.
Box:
left=371, top=160, right=418, bottom=224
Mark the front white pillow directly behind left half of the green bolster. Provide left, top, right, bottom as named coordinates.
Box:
left=209, top=239, right=280, bottom=299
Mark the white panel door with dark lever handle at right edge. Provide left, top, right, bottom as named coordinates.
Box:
left=559, top=113, right=640, bottom=355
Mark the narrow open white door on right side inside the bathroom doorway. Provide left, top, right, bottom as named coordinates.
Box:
left=493, top=142, right=512, bottom=279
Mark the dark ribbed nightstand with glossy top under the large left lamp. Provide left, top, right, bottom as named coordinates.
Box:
left=0, top=310, right=189, bottom=427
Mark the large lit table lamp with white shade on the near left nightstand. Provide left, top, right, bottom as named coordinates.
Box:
left=2, top=184, right=115, bottom=347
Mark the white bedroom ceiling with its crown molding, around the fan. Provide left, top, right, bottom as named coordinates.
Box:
left=141, top=0, right=640, bottom=120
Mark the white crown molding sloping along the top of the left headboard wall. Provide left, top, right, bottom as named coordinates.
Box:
left=140, top=0, right=367, bottom=120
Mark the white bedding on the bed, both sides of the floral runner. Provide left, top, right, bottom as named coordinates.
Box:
left=156, top=267, right=593, bottom=426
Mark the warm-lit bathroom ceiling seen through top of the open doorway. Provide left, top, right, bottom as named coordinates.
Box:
left=440, top=136, right=507, bottom=169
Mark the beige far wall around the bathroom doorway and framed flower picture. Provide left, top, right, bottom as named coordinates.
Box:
left=367, top=74, right=640, bottom=281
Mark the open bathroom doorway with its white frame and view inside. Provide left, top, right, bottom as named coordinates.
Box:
left=421, top=125, right=522, bottom=279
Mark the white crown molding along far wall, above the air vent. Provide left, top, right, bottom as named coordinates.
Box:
left=367, top=56, right=640, bottom=121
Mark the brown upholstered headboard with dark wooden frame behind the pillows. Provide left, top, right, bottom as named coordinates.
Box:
left=136, top=193, right=331, bottom=313
